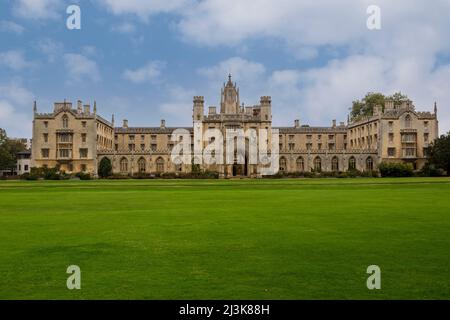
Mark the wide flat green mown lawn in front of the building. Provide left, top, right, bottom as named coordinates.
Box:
left=0, top=178, right=450, bottom=299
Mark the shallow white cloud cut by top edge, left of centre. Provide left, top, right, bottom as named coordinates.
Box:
left=101, top=0, right=192, bottom=20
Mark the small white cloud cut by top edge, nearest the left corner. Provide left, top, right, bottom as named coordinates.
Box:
left=13, top=0, right=63, bottom=20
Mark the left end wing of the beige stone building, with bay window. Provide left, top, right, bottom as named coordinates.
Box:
left=31, top=101, right=114, bottom=173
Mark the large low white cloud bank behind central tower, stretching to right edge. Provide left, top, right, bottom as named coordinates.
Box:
left=196, top=55, right=450, bottom=132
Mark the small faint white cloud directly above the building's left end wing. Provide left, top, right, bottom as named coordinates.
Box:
left=64, top=53, right=101, bottom=83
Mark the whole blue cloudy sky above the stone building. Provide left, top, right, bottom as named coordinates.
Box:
left=0, top=0, right=450, bottom=137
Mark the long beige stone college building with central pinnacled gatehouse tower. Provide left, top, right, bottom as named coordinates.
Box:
left=32, top=76, right=438, bottom=177
